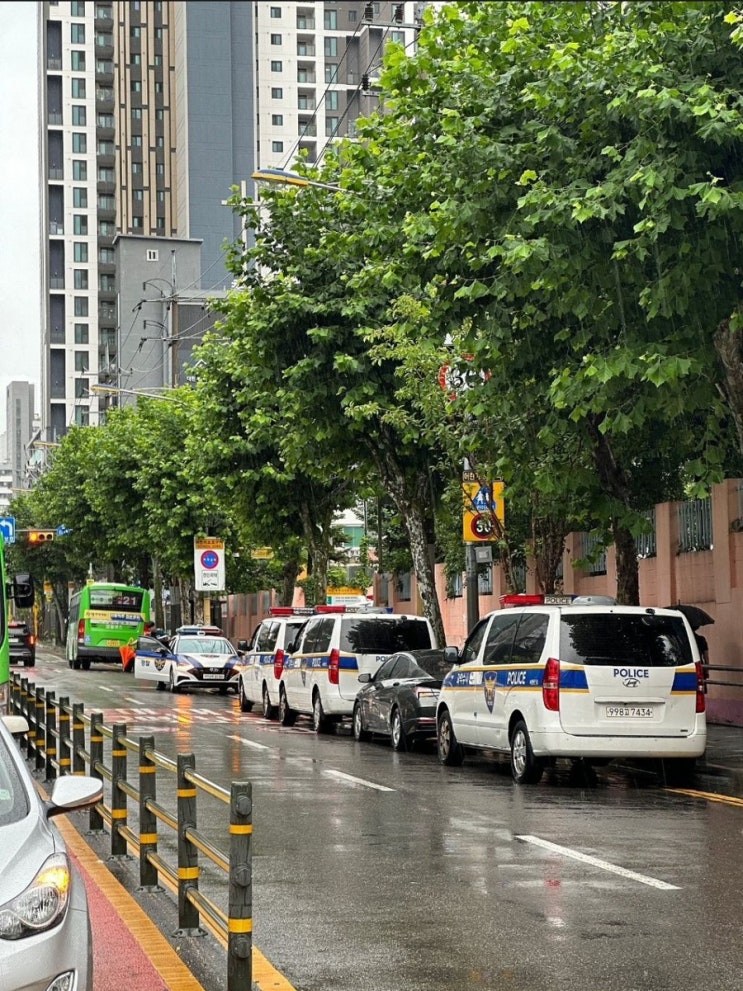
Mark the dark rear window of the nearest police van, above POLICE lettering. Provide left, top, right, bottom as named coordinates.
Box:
left=560, top=612, right=693, bottom=668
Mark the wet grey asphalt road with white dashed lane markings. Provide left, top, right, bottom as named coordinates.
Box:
left=20, top=651, right=743, bottom=991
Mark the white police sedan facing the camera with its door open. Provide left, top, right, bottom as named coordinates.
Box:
left=134, top=633, right=242, bottom=692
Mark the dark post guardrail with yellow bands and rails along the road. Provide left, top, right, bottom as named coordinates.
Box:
left=10, top=673, right=253, bottom=991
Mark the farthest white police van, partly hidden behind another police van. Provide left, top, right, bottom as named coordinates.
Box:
left=238, top=606, right=314, bottom=719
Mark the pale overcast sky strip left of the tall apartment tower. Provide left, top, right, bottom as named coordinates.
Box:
left=0, top=2, right=41, bottom=432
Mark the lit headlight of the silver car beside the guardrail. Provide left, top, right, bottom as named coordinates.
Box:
left=0, top=853, right=71, bottom=939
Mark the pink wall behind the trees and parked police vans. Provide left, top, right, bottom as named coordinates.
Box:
left=223, top=479, right=743, bottom=726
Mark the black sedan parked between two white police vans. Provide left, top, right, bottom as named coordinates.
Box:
left=353, top=650, right=451, bottom=750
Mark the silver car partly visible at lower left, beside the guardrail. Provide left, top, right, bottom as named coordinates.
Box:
left=0, top=716, right=103, bottom=991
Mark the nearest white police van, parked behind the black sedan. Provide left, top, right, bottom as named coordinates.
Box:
left=436, top=595, right=707, bottom=784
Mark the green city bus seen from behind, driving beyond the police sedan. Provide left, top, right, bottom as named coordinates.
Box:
left=65, top=582, right=150, bottom=671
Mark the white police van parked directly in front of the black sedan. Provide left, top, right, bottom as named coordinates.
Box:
left=279, top=606, right=438, bottom=733
